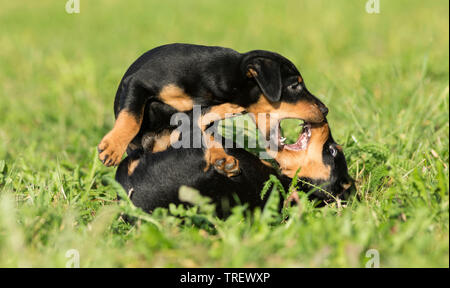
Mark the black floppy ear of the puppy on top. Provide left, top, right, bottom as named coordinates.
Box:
left=245, top=57, right=281, bottom=102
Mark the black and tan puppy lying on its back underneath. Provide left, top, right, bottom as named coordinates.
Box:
left=116, top=123, right=353, bottom=216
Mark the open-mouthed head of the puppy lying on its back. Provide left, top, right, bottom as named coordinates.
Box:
left=269, top=122, right=354, bottom=201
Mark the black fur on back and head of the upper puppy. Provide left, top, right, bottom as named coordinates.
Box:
left=114, top=44, right=328, bottom=119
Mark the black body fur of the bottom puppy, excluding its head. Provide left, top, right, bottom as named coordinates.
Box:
left=116, top=148, right=282, bottom=216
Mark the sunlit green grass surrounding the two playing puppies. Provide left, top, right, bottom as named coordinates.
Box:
left=0, top=0, right=449, bottom=267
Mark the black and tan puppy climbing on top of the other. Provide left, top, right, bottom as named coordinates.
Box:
left=98, top=44, right=328, bottom=176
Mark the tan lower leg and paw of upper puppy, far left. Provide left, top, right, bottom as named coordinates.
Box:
left=98, top=110, right=142, bottom=166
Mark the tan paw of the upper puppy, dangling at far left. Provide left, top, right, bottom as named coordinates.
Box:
left=97, top=134, right=127, bottom=167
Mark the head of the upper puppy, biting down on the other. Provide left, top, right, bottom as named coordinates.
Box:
left=241, top=50, right=328, bottom=124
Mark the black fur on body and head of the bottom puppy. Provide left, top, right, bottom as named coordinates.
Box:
left=116, top=126, right=353, bottom=216
